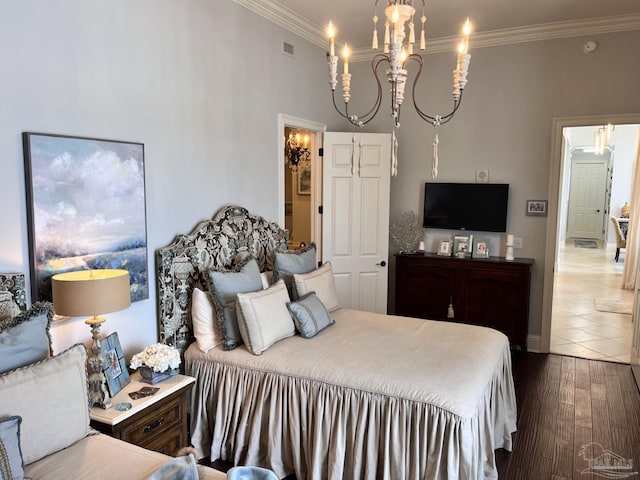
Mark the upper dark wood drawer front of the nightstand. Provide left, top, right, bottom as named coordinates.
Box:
left=120, top=397, right=186, bottom=446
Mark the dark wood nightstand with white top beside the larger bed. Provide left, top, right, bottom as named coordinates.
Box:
left=89, top=372, right=196, bottom=455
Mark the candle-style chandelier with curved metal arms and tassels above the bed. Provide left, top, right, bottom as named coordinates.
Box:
left=327, top=0, right=471, bottom=178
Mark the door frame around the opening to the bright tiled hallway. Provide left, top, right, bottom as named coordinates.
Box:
left=539, top=113, right=640, bottom=353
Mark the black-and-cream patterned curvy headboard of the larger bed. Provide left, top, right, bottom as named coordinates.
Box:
left=156, top=206, right=289, bottom=352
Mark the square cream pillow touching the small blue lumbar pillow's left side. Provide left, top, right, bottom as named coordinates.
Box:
left=236, top=280, right=296, bottom=355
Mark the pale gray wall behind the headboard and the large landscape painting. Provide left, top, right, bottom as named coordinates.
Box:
left=0, top=0, right=333, bottom=355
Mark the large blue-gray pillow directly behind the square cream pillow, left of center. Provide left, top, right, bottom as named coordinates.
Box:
left=209, top=258, right=262, bottom=350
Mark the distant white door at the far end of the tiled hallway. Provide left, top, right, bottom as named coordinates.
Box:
left=567, top=160, right=607, bottom=240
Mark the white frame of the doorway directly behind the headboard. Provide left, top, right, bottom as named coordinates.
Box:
left=276, top=113, right=327, bottom=251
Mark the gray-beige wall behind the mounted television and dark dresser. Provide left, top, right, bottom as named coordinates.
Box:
left=350, top=32, right=640, bottom=335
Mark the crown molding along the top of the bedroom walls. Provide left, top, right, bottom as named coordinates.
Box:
left=234, top=0, right=640, bottom=62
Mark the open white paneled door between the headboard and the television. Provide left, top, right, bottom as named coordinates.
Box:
left=322, top=132, right=391, bottom=313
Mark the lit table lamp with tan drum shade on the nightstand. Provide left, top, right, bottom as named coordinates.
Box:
left=51, top=269, right=131, bottom=408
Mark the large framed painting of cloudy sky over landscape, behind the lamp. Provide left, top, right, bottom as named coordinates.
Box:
left=22, top=132, right=149, bottom=303
